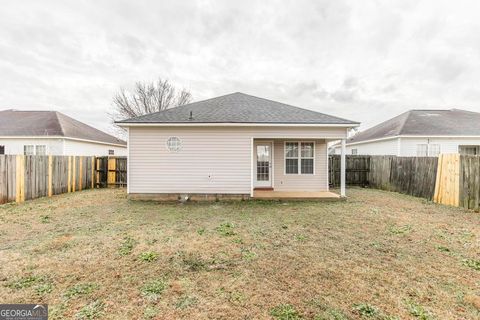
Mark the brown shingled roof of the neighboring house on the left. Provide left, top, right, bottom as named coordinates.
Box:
left=0, top=110, right=127, bottom=145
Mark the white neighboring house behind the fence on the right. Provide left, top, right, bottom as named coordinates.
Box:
left=333, top=109, right=480, bottom=157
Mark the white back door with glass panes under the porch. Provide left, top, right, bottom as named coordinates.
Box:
left=254, top=142, right=272, bottom=188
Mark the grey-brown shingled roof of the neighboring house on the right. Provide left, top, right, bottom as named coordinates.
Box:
left=348, top=109, right=480, bottom=143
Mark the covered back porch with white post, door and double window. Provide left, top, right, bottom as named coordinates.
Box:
left=250, top=137, right=346, bottom=200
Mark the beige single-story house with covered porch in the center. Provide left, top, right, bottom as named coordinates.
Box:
left=117, top=92, right=358, bottom=199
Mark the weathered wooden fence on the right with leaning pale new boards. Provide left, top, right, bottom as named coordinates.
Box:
left=329, top=154, right=480, bottom=210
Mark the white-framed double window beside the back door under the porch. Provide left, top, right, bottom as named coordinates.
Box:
left=285, top=141, right=315, bottom=174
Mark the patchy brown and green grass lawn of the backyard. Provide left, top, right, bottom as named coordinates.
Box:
left=0, top=189, right=480, bottom=320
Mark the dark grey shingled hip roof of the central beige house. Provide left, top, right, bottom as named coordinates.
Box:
left=117, top=92, right=358, bottom=126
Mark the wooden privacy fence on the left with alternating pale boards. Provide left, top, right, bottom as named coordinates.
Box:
left=0, top=155, right=126, bottom=204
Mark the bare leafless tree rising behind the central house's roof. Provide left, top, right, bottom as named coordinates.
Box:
left=111, top=79, right=192, bottom=121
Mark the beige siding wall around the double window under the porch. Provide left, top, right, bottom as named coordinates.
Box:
left=273, top=140, right=328, bottom=191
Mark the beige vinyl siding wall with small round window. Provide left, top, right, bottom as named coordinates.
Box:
left=129, top=127, right=346, bottom=194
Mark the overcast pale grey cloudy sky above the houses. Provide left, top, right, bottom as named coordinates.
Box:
left=0, top=0, right=480, bottom=136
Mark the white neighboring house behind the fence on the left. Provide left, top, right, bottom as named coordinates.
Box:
left=0, top=110, right=127, bottom=156
